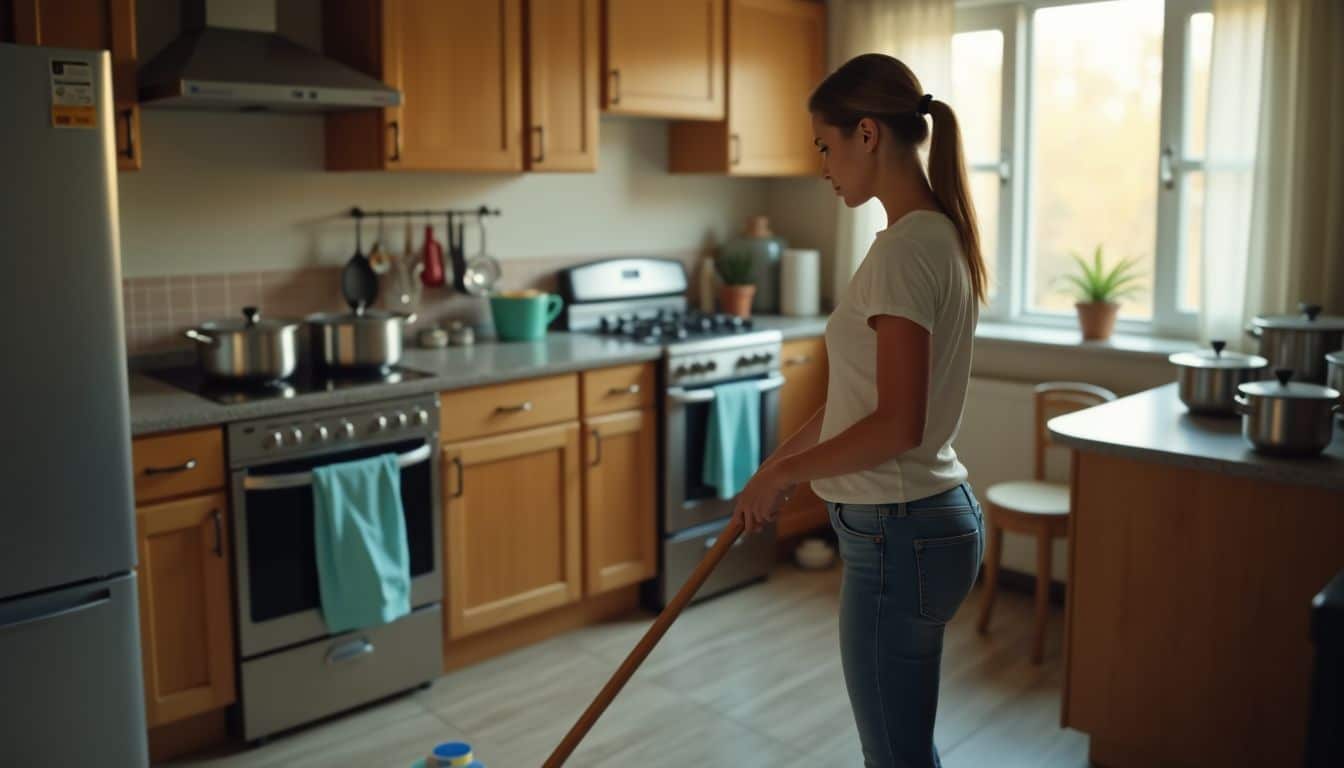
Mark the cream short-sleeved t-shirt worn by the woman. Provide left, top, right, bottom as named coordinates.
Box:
left=812, top=211, right=980, bottom=504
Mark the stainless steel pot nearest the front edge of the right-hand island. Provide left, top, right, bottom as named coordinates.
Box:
left=1236, top=369, right=1340, bottom=456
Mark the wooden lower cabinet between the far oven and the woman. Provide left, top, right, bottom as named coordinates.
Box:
left=777, top=338, right=828, bottom=538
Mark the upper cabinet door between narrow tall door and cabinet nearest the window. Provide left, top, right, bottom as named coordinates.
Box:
left=602, top=0, right=724, bottom=120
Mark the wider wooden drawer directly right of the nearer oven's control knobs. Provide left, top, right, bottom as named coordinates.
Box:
left=438, top=374, right=579, bottom=443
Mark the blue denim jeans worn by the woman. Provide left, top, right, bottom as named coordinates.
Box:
left=827, top=483, right=984, bottom=768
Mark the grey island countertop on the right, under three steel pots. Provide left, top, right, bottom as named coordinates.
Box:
left=1050, top=383, right=1344, bottom=491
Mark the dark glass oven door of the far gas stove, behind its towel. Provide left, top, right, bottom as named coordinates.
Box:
left=663, top=373, right=784, bottom=535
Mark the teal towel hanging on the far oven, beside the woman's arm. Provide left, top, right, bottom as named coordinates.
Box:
left=702, top=381, right=761, bottom=499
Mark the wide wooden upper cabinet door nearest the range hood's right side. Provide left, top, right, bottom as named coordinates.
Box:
left=382, top=0, right=523, bottom=171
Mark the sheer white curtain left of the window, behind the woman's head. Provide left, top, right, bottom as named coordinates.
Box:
left=829, top=0, right=956, bottom=301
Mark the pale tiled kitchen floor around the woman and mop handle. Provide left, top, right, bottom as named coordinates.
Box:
left=170, top=565, right=1087, bottom=768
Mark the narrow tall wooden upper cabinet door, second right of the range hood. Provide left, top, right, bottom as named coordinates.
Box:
left=523, top=0, right=599, bottom=171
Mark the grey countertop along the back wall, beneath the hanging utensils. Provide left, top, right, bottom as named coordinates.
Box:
left=130, top=316, right=827, bottom=437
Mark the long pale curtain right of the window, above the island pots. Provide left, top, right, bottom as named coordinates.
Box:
left=1202, top=0, right=1344, bottom=339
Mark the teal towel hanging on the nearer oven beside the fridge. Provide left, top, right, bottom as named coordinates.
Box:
left=313, top=453, right=411, bottom=633
